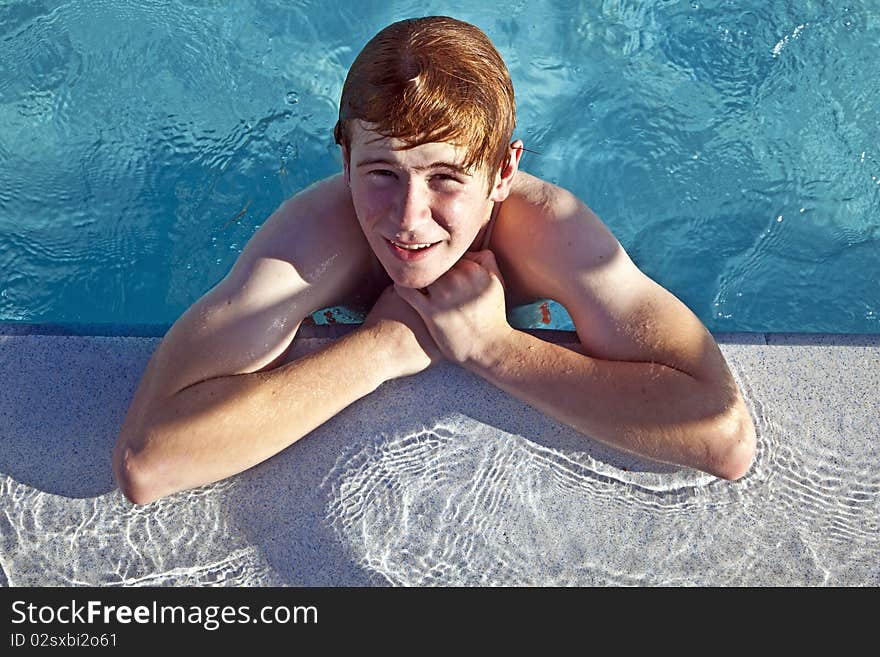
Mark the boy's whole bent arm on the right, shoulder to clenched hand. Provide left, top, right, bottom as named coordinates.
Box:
left=400, top=182, right=755, bottom=479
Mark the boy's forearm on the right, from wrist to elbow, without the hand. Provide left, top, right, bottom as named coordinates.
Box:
left=465, top=330, right=753, bottom=478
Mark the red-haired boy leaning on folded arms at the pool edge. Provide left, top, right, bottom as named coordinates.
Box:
left=113, top=17, right=755, bottom=504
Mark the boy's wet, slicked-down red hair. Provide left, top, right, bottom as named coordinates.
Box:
left=333, top=16, right=516, bottom=187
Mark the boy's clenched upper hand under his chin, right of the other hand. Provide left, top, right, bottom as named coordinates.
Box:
left=394, top=249, right=513, bottom=365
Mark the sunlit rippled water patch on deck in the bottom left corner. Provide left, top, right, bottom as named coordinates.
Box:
left=0, top=477, right=276, bottom=586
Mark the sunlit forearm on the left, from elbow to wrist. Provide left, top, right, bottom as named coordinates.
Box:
left=114, top=330, right=388, bottom=503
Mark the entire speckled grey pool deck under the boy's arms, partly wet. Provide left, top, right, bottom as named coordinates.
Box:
left=0, top=324, right=880, bottom=586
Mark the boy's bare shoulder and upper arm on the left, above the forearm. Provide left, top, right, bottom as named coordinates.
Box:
left=134, top=177, right=368, bottom=408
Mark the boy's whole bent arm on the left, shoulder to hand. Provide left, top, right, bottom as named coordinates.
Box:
left=113, top=180, right=442, bottom=504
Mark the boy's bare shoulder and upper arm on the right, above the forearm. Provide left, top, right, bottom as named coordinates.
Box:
left=496, top=169, right=730, bottom=390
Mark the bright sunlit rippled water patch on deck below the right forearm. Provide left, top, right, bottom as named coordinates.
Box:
left=324, top=421, right=741, bottom=586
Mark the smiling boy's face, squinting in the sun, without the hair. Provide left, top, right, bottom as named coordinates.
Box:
left=343, top=121, right=509, bottom=288
